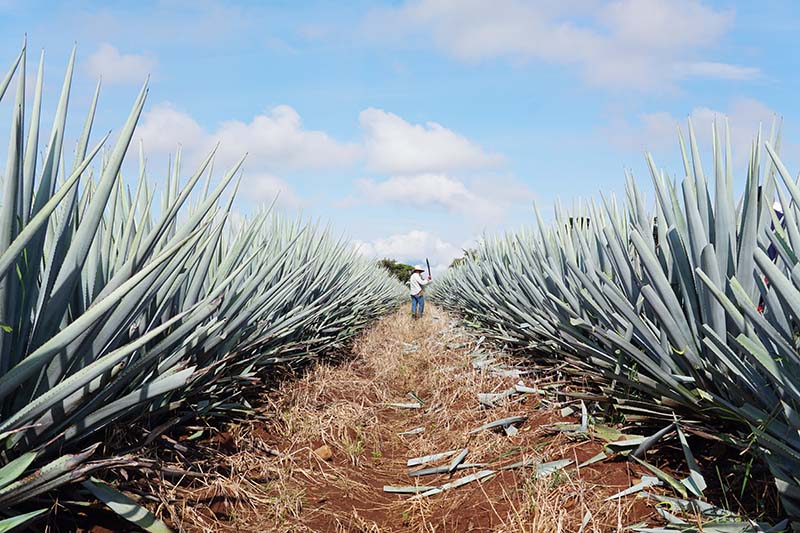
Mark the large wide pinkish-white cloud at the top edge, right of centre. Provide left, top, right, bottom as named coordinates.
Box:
left=366, top=0, right=758, bottom=89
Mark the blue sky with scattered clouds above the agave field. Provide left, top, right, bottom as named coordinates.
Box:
left=0, top=0, right=800, bottom=273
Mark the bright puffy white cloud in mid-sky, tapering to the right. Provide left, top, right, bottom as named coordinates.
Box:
left=359, top=108, right=502, bottom=174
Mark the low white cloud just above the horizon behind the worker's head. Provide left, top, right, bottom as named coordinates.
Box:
left=353, top=230, right=463, bottom=275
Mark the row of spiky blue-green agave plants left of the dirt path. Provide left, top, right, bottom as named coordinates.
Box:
left=0, top=42, right=403, bottom=531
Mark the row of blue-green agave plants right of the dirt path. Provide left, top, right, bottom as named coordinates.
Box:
left=432, top=117, right=800, bottom=518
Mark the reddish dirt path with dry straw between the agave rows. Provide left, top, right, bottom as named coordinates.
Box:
left=166, top=308, right=652, bottom=532
